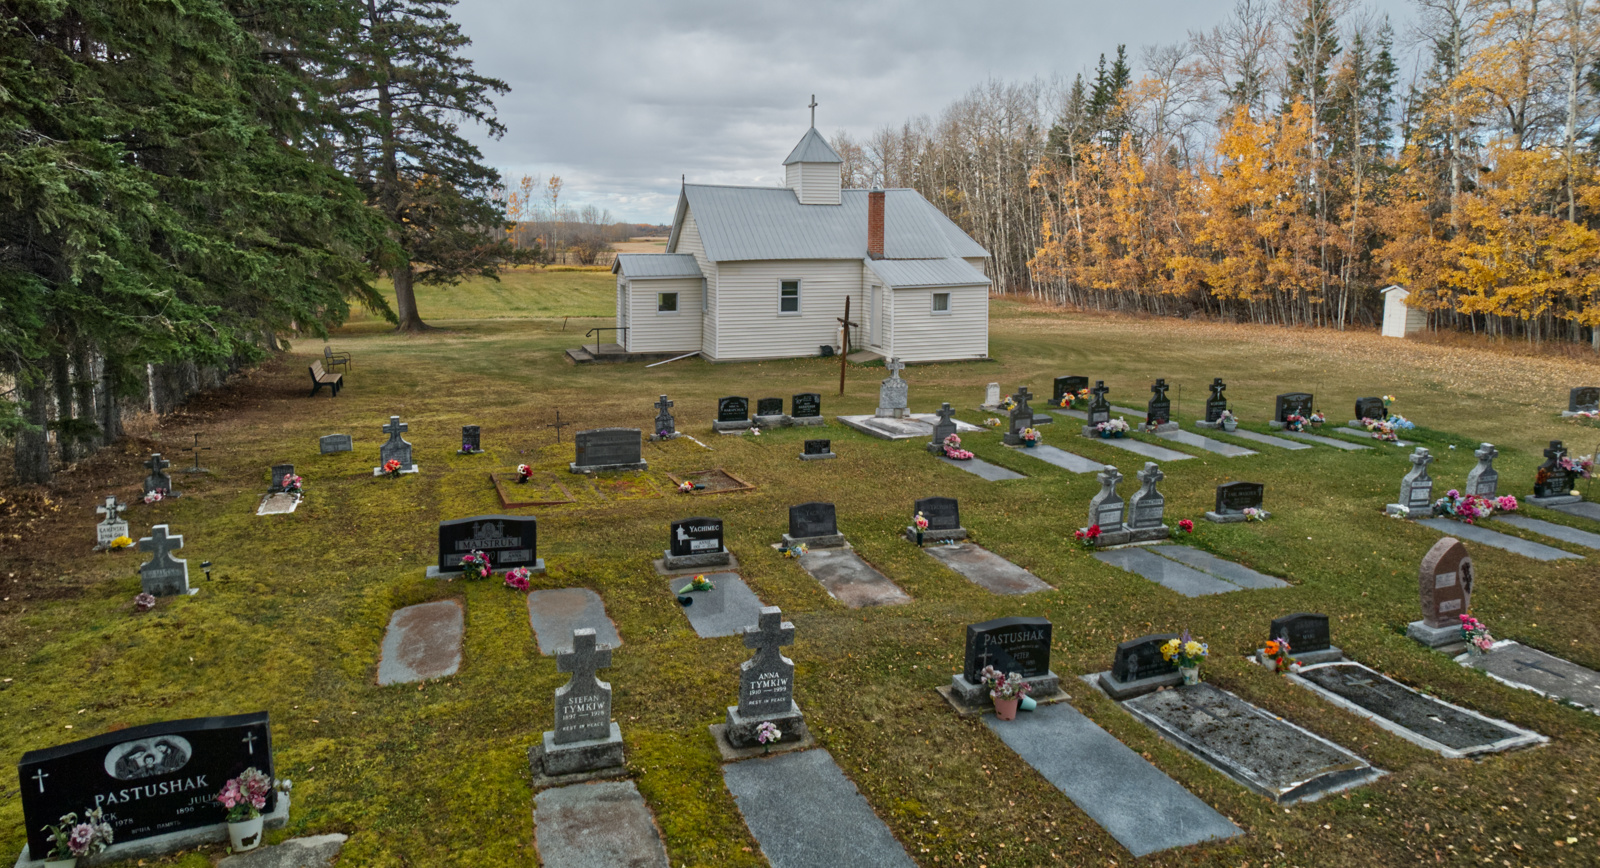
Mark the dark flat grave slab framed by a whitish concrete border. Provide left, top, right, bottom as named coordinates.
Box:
left=1288, top=661, right=1549, bottom=759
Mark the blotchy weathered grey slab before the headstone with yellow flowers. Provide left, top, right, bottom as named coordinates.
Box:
left=1122, top=684, right=1382, bottom=804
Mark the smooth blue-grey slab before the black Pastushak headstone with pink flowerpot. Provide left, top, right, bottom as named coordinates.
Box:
left=984, top=703, right=1243, bottom=858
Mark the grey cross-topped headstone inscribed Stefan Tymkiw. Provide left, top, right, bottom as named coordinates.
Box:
left=542, top=628, right=622, bottom=777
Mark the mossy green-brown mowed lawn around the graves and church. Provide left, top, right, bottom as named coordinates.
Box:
left=0, top=271, right=1600, bottom=866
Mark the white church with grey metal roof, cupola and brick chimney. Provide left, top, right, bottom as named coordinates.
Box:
left=611, top=127, right=990, bottom=362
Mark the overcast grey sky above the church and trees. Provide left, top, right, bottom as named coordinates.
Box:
left=454, top=0, right=1410, bottom=223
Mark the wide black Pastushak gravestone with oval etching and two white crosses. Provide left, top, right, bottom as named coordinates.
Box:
left=16, top=711, right=275, bottom=865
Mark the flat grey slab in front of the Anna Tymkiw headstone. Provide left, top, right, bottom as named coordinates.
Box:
left=723, top=748, right=917, bottom=868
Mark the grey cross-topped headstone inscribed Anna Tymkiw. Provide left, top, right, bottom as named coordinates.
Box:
left=723, top=605, right=806, bottom=748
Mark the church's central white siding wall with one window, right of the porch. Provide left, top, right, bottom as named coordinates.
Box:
left=707, top=259, right=861, bottom=362
